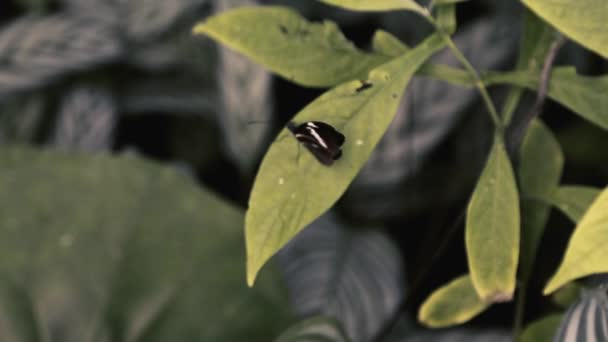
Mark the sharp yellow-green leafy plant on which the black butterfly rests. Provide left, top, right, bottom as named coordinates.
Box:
left=194, top=0, right=608, bottom=341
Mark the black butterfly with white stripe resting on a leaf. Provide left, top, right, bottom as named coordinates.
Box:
left=287, top=121, right=345, bottom=166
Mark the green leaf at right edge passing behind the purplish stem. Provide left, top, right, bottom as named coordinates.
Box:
left=484, top=67, right=608, bottom=129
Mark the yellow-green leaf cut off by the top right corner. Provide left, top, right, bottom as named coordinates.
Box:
left=522, top=0, right=608, bottom=58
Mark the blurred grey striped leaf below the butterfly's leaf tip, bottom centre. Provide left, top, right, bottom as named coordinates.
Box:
left=277, top=213, right=406, bottom=342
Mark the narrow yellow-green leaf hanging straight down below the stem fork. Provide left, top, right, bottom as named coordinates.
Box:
left=465, top=134, right=520, bottom=302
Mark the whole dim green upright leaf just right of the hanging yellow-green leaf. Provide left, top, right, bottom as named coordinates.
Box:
left=518, top=120, right=564, bottom=279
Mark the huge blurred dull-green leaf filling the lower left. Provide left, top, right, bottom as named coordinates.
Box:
left=0, top=147, right=290, bottom=342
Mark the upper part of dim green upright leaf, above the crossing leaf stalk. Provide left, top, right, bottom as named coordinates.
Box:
left=518, top=120, right=564, bottom=198
